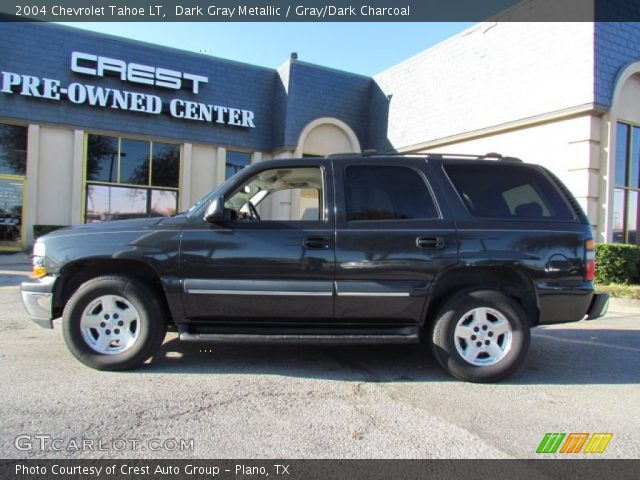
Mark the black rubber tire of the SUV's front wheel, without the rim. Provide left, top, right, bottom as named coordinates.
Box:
left=62, top=276, right=167, bottom=371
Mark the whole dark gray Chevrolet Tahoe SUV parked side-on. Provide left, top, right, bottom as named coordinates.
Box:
left=22, top=154, right=608, bottom=382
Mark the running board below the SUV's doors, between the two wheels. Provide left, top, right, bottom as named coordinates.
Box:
left=180, top=332, right=420, bottom=345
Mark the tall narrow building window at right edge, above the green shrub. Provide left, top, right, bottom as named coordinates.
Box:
left=613, top=122, right=640, bottom=245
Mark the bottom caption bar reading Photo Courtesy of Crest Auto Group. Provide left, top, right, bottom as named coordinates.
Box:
left=0, top=459, right=640, bottom=480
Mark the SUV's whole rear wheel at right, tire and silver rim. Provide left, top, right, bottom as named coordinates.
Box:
left=431, top=290, right=530, bottom=382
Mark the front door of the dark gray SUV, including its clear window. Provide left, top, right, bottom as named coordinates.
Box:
left=180, top=160, right=335, bottom=323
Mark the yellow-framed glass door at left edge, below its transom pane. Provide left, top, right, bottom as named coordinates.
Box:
left=0, top=175, right=25, bottom=251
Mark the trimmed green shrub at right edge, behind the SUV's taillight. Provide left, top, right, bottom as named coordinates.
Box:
left=596, top=243, right=640, bottom=285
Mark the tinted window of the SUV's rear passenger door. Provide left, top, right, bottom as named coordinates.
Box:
left=345, top=165, right=438, bottom=221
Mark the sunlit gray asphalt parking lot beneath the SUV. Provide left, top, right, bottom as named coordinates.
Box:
left=0, top=267, right=640, bottom=458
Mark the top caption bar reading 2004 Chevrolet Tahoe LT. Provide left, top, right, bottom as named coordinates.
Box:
left=0, top=0, right=640, bottom=23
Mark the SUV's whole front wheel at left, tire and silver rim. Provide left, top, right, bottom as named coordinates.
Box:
left=62, top=276, right=167, bottom=370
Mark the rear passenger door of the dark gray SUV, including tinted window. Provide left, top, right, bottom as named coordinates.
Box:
left=334, top=158, right=458, bottom=324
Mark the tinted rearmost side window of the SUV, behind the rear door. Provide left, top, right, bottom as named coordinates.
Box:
left=444, top=164, right=575, bottom=220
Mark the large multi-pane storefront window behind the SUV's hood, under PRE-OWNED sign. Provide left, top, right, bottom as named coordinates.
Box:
left=85, top=135, right=180, bottom=223
